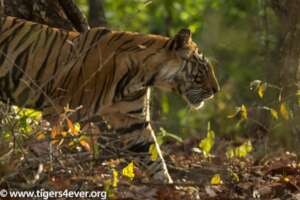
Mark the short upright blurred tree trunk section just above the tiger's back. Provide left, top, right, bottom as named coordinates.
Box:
left=88, top=0, right=107, bottom=27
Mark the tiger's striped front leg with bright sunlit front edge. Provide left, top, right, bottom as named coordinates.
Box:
left=105, top=113, right=173, bottom=183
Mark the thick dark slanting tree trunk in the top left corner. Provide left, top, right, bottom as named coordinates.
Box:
left=0, top=0, right=89, bottom=32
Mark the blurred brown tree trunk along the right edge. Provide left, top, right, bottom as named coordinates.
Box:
left=271, top=0, right=300, bottom=141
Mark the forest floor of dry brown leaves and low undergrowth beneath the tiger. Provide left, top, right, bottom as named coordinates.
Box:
left=0, top=107, right=300, bottom=200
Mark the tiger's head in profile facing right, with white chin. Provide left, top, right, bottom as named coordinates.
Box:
left=154, top=29, right=219, bottom=109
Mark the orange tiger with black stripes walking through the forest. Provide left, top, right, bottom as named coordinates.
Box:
left=0, top=16, right=220, bottom=183
